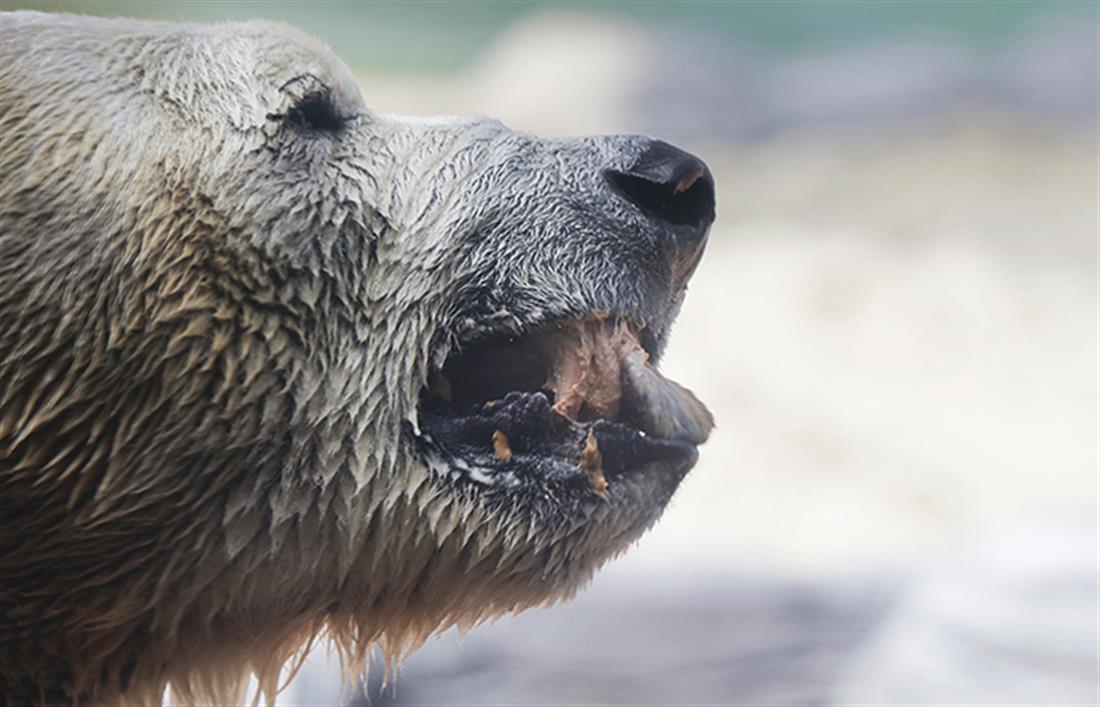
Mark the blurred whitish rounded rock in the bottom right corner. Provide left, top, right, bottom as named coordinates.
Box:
left=829, top=523, right=1100, bottom=705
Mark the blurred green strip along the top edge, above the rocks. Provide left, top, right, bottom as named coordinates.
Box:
left=0, top=0, right=1097, bottom=71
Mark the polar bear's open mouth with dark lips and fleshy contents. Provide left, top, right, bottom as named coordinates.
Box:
left=416, top=313, right=714, bottom=500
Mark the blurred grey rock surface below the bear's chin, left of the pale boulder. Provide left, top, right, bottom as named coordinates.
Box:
left=288, top=572, right=893, bottom=707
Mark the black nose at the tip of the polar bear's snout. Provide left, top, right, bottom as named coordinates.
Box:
left=605, top=140, right=714, bottom=228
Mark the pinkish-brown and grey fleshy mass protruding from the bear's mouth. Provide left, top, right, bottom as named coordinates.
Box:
left=537, top=314, right=714, bottom=444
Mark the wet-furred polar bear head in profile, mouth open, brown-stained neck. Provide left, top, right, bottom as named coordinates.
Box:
left=0, top=12, right=714, bottom=704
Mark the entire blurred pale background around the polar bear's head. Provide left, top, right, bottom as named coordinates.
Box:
left=10, top=0, right=1100, bottom=705
